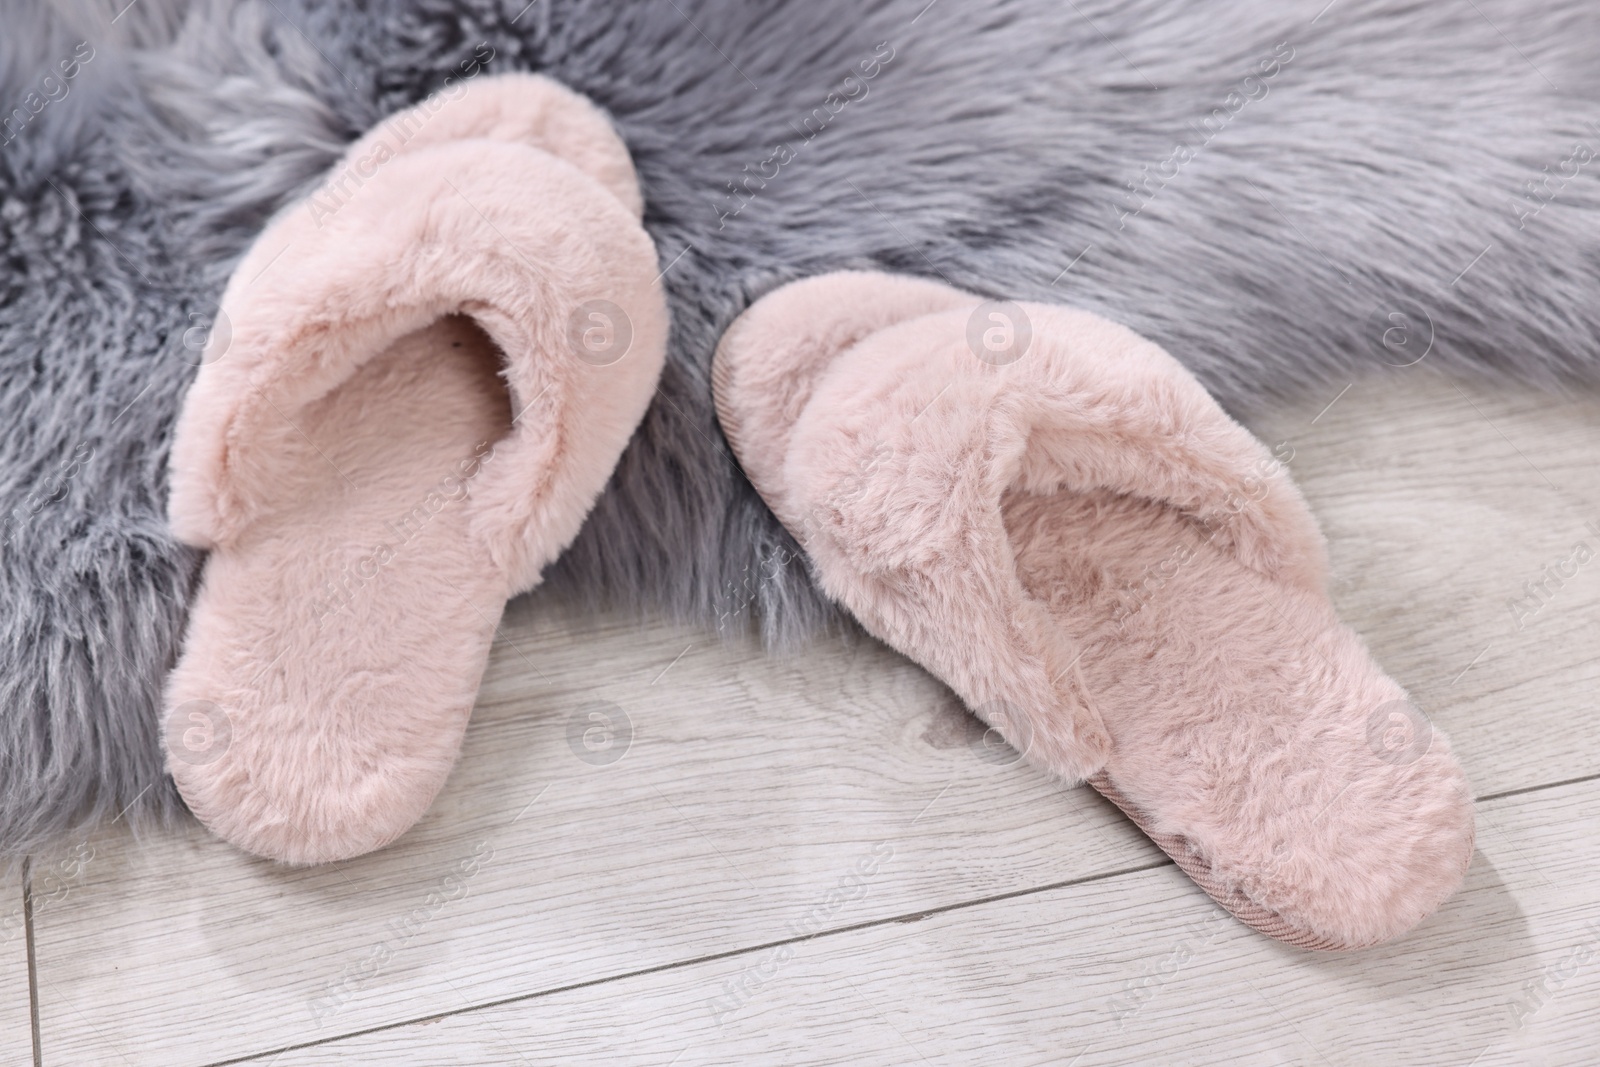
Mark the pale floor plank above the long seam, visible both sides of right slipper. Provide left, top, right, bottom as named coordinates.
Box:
left=37, top=374, right=1600, bottom=1065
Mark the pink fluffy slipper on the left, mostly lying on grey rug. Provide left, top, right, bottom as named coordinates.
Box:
left=166, top=75, right=667, bottom=862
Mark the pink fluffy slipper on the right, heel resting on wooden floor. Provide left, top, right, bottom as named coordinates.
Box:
left=714, top=274, right=1474, bottom=949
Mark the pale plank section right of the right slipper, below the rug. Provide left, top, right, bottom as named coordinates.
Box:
left=1251, top=365, right=1600, bottom=795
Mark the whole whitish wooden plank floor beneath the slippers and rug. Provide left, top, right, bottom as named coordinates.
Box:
left=9, top=366, right=1600, bottom=1067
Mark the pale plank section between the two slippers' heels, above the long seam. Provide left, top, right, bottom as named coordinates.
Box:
left=37, top=601, right=1160, bottom=1067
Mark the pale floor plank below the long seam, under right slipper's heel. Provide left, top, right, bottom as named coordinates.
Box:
left=243, top=782, right=1600, bottom=1067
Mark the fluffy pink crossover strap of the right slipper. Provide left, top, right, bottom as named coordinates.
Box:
left=776, top=298, right=1326, bottom=779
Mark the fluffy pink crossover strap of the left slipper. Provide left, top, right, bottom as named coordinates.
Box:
left=162, top=141, right=667, bottom=589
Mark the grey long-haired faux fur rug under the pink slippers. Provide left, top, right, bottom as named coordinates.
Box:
left=0, top=0, right=1600, bottom=856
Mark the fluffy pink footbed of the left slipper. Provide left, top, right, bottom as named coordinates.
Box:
left=170, top=317, right=512, bottom=862
